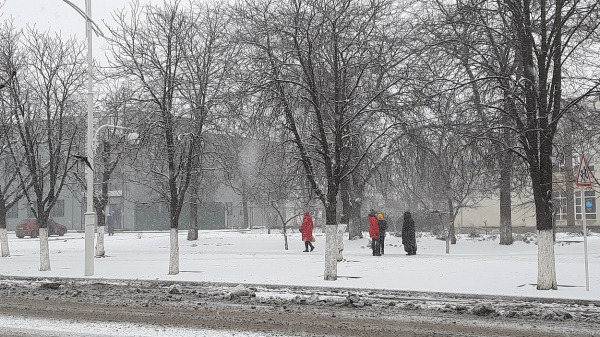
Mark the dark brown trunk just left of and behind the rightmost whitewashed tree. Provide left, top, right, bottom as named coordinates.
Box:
left=500, top=150, right=513, bottom=245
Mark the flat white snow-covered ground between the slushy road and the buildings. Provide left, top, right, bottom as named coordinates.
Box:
left=0, top=229, right=600, bottom=300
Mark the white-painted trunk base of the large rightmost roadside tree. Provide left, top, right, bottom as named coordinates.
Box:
left=537, top=229, right=557, bottom=290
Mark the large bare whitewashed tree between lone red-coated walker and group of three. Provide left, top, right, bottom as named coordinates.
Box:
left=238, top=1, right=406, bottom=280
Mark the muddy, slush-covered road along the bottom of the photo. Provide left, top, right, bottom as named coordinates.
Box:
left=0, top=277, right=600, bottom=337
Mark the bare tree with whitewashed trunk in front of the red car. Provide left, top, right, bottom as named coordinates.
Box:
left=9, top=29, right=85, bottom=271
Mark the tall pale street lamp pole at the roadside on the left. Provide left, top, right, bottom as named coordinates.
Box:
left=63, top=0, right=104, bottom=276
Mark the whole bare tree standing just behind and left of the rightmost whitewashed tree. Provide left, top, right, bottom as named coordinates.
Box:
left=428, top=1, right=516, bottom=245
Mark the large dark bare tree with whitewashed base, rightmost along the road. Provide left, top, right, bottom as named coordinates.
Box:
left=424, top=0, right=599, bottom=290
